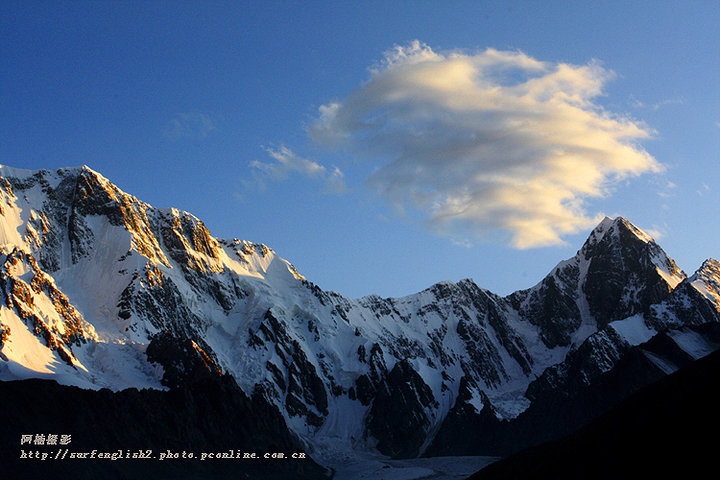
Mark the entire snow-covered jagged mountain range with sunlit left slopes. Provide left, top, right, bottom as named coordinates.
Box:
left=0, top=167, right=720, bottom=462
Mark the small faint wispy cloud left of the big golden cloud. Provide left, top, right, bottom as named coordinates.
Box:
left=250, top=145, right=347, bottom=193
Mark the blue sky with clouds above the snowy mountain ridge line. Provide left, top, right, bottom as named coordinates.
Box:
left=0, top=1, right=720, bottom=297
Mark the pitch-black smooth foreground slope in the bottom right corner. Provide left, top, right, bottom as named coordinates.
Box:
left=468, top=342, right=720, bottom=480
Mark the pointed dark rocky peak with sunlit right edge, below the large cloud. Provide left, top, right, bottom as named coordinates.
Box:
left=508, top=217, right=686, bottom=348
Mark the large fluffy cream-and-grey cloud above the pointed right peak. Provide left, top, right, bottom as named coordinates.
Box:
left=309, top=41, right=662, bottom=248
